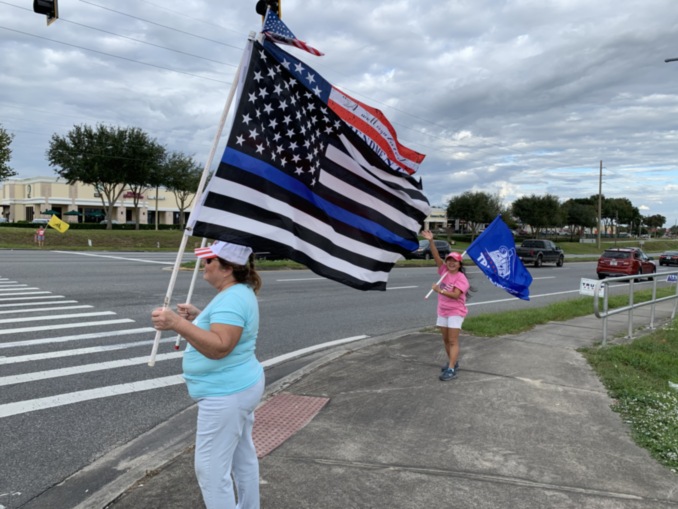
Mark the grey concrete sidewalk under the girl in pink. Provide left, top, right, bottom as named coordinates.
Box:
left=93, top=303, right=678, bottom=509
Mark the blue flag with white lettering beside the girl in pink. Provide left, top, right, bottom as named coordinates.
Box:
left=466, top=216, right=532, bottom=300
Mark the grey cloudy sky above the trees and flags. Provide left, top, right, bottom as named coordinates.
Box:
left=0, top=0, right=678, bottom=222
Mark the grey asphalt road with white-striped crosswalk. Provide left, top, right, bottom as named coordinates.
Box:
left=0, top=250, right=660, bottom=509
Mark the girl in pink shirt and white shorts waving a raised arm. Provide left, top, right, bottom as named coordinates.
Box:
left=421, top=230, right=470, bottom=382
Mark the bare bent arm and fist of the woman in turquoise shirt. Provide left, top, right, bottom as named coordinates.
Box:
left=151, top=308, right=242, bottom=360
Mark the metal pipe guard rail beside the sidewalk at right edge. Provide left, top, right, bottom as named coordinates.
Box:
left=593, top=270, right=678, bottom=346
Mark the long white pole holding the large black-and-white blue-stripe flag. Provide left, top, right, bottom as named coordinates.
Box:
left=148, top=32, right=256, bottom=367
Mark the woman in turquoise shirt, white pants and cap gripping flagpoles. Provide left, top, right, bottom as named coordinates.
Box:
left=151, top=241, right=264, bottom=509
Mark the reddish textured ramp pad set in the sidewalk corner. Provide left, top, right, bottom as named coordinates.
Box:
left=252, top=393, right=329, bottom=458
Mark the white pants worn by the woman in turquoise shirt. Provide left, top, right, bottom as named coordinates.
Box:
left=195, top=376, right=265, bottom=509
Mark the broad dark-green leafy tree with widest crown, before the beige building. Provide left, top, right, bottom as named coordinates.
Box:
left=47, top=124, right=164, bottom=229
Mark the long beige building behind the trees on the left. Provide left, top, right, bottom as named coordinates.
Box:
left=0, top=177, right=193, bottom=224
